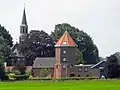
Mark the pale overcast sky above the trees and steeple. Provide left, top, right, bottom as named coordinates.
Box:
left=0, top=0, right=120, bottom=57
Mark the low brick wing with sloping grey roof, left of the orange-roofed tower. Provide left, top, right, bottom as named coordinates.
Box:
left=32, top=57, right=55, bottom=77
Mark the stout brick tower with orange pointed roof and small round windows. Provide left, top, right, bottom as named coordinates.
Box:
left=54, top=31, right=77, bottom=79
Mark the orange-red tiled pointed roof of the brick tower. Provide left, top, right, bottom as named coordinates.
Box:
left=55, top=31, right=77, bottom=46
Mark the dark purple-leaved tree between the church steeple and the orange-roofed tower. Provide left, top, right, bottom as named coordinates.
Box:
left=21, top=30, right=55, bottom=65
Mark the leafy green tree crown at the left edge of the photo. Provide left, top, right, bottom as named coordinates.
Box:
left=0, top=25, right=13, bottom=62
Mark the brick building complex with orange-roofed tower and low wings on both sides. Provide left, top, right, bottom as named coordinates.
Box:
left=32, top=32, right=101, bottom=79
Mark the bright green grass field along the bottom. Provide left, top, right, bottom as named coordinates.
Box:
left=0, top=80, right=120, bottom=90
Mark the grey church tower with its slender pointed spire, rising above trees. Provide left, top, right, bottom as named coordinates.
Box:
left=19, top=8, right=28, bottom=43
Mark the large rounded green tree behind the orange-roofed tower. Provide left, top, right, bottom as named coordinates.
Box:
left=51, top=23, right=99, bottom=64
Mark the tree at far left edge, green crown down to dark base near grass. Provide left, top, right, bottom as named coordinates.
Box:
left=0, top=25, right=12, bottom=80
